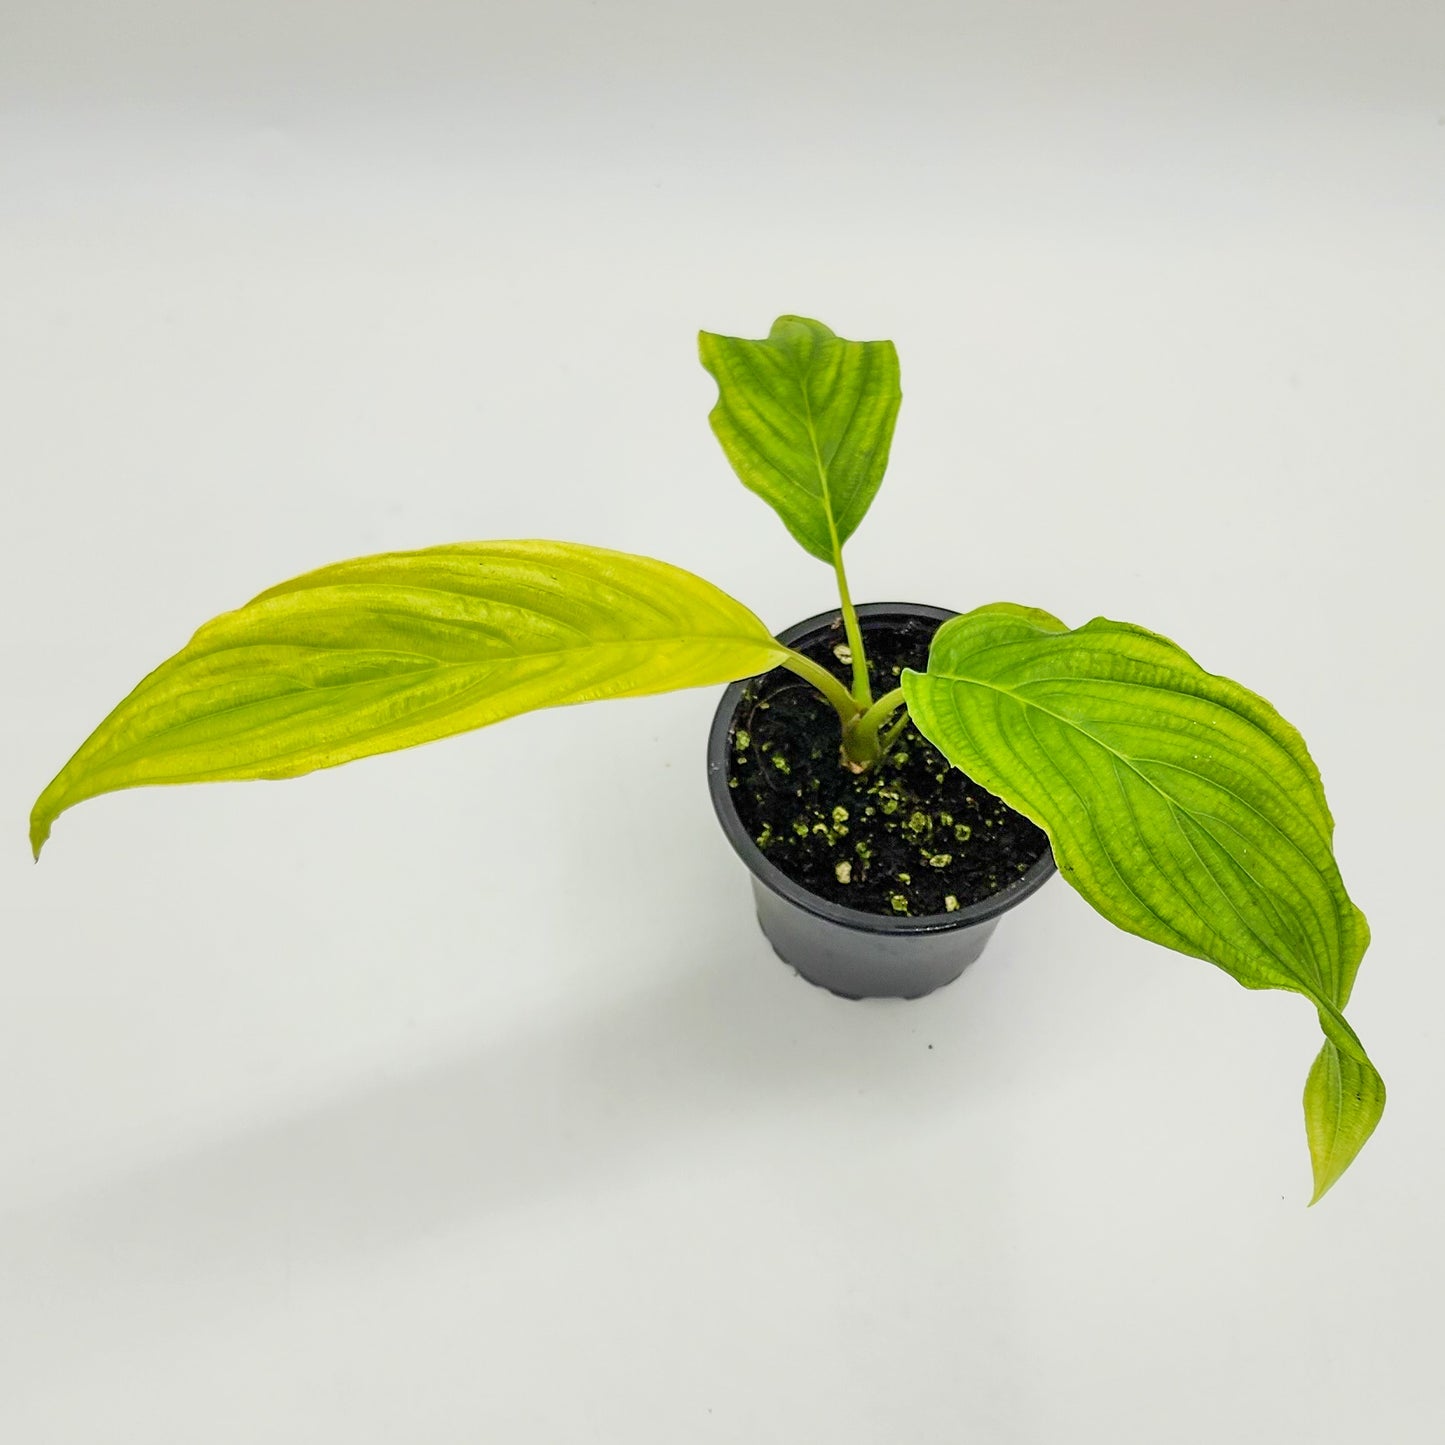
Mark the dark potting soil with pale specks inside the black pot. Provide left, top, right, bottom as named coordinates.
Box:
left=728, top=618, right=1049, bottom=916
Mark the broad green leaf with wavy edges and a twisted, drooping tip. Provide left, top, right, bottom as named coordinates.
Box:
left=903, top=604, right=1384, bottom=1198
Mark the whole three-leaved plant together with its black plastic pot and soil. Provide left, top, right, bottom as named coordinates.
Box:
left=30, top=316, right=1384, bottom=1202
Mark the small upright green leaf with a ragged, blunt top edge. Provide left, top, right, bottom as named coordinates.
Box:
left=698, top=316, right=903, bottom=564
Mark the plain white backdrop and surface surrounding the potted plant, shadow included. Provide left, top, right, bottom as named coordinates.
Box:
left=0, top=0, right=1445, bottom=1445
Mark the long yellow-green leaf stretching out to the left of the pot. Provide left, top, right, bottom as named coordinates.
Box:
left=30, top=542, right=785, bottom=857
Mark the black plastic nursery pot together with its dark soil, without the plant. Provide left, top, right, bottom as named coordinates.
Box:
left=708, top=603, right=1055, bottom=998
